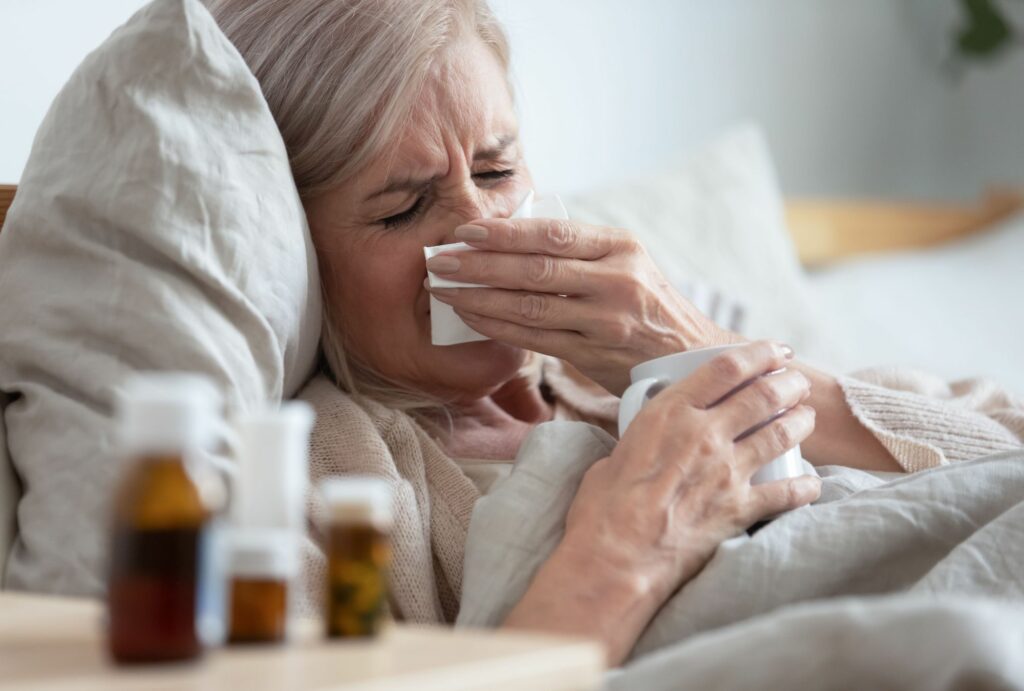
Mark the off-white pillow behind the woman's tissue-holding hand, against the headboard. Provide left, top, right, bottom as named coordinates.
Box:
left=566, top=126, right=835, bottom=370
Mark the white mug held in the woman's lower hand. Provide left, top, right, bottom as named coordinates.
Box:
left=618, top=345, right=809, bottom=484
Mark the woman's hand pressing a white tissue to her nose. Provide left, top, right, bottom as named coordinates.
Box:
left=427, top=219, right=740, bottom=395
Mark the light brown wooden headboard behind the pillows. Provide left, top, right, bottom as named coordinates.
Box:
left=0, top=185, right=1024, bottom=266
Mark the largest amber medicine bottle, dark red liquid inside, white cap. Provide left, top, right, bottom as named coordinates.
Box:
left=108, top=373, right=220, bottom=663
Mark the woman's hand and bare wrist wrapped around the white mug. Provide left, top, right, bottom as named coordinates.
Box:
left=506, top=342, right=821, bottom=663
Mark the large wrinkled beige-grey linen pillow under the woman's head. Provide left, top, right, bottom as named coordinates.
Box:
left=0, top=0, right=321, bottom=594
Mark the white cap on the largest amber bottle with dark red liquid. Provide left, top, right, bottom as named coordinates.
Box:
left=115, top=372, right=222, bottom=455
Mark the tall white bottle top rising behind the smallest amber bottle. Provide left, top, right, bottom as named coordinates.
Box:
left=231, top=401, right=314, bottom=533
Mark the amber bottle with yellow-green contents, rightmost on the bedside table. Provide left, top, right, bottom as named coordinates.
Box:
left=319, top=476, right=392, bottom=638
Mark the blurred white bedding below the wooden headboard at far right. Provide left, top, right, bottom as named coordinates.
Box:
left=810, top=214, right=1024, bottom=396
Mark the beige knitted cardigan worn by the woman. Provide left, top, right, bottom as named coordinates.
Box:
left=299, top=361, right=1024, bottom=622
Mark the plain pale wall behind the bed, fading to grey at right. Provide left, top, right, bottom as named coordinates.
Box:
left=0, top=0, right=1024, bottom=197
